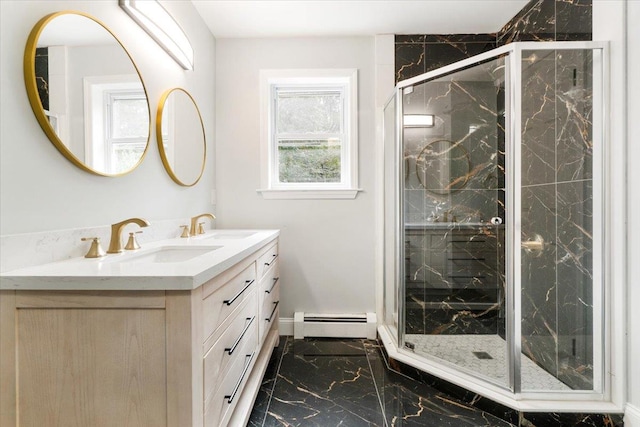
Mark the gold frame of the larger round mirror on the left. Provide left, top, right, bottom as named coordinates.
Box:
left=23, top=10, right=151, bottom=177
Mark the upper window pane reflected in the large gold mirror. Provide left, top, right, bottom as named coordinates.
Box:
left=111, top=98, right=149, bottom=139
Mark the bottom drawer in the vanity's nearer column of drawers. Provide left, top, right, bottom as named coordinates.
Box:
left=204, top=336, right=258, bottom=427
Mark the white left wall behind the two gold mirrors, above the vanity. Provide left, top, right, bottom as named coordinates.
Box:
left=0, top=0, right=215, bottom=235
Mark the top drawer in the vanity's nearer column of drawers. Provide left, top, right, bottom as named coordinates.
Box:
left=202, top=263, right=257, bottom=340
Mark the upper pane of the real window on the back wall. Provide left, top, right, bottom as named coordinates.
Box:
left=276, top=90, right=342, bottom=133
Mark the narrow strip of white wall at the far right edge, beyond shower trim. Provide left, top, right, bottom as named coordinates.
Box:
left=625, top=0, right=640, bottom=427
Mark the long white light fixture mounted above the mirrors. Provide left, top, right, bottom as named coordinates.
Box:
left=120, top=0, right=193, bottom=70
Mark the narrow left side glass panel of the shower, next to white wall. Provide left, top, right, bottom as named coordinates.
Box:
left=384, top=96, right=400, bottom=340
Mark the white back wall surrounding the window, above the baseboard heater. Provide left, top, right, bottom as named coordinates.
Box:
left=216, top=37, right=375, bottom=317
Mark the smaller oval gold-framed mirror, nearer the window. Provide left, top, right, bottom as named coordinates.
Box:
left=156, top=88, right=207, bottom=187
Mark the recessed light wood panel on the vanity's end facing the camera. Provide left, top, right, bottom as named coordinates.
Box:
left=16, top=308, right=167, bottom=427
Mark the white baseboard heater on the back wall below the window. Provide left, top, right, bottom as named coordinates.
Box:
left=293, top=311, right=377, bottom=340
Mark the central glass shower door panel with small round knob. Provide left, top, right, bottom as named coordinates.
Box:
left=402, top=58, right=511, bottom=388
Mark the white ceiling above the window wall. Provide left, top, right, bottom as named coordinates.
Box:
left=192, top=0, right=528, bottom=38
